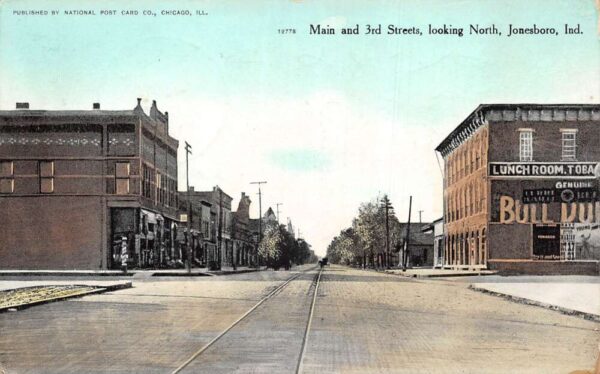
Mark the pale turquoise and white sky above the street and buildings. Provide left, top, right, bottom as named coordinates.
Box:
left=0, top=0, right=600, bottom=255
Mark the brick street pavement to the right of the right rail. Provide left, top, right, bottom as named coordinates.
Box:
left=305, top=267, right=600, bottom=374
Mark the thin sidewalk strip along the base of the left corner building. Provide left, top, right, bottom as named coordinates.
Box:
left=0, top=266, right=264, bottom=278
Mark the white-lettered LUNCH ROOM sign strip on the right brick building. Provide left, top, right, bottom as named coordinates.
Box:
left=489, top=162, right=599, bottom=178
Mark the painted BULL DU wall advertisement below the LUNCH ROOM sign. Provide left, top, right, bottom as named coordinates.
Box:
left=491, top=177, right=600, bottom=261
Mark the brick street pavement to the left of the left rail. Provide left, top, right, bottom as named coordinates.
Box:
left=0, top=271, right=304, bottom=374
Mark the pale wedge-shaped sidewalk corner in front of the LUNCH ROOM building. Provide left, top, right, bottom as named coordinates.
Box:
left=469, top=277, right=600, bottom=322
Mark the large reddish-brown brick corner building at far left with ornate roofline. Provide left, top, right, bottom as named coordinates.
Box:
left=0, top=99, right=178, bottom=269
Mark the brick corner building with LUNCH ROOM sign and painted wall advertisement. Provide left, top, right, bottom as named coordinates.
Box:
left=436, top=104, right=600, bottom=274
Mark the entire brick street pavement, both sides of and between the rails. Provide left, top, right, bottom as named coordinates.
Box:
left=0, top=266, right=600, bottom=374
